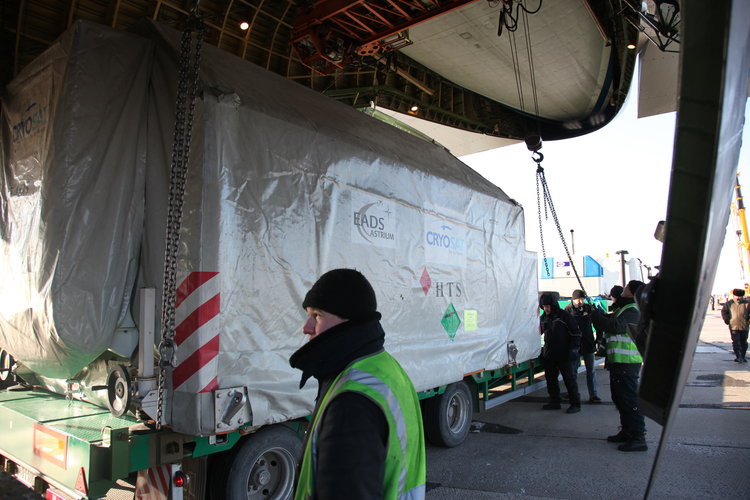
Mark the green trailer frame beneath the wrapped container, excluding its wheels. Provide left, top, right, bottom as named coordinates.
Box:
left=0, top=350, right=545, bottom=498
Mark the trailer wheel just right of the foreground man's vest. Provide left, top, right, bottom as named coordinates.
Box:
left=422, top=381, right=472, bottom=448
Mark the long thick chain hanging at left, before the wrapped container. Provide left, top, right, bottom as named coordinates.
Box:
left=156, top=9, right=205, bottom=429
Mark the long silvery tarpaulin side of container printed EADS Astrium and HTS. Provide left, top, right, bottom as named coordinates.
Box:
left=137, top=21, right=540, bottom=432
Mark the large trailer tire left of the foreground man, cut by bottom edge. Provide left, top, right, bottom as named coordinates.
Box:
left=211, top=425, right=302, bottom=500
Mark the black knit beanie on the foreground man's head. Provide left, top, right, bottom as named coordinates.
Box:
left=302, top=269, right=378, bottom=319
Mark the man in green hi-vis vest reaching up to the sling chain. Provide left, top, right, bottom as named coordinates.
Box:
left=591, top=280, right=648, bottom=451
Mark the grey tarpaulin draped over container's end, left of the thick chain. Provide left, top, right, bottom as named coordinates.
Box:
left=0, top=23, right=152, bottom=379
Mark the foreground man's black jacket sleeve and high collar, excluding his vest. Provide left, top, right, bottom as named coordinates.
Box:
left=289, top=313, right=388, bottom=499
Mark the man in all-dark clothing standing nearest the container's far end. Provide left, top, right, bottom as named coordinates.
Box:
left=539, top=293, right=581, bottom=413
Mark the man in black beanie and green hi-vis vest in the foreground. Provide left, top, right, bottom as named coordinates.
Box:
left=290, top=269, right=426, bottom=499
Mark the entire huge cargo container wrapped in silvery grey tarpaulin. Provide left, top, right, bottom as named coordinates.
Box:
left=0, top=18, right=540, bottom=435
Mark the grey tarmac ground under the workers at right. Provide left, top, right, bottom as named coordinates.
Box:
left=427, top=309, right=750, bottom=500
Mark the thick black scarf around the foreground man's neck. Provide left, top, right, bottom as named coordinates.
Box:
left=289, top=312, right=385, bottom=389
